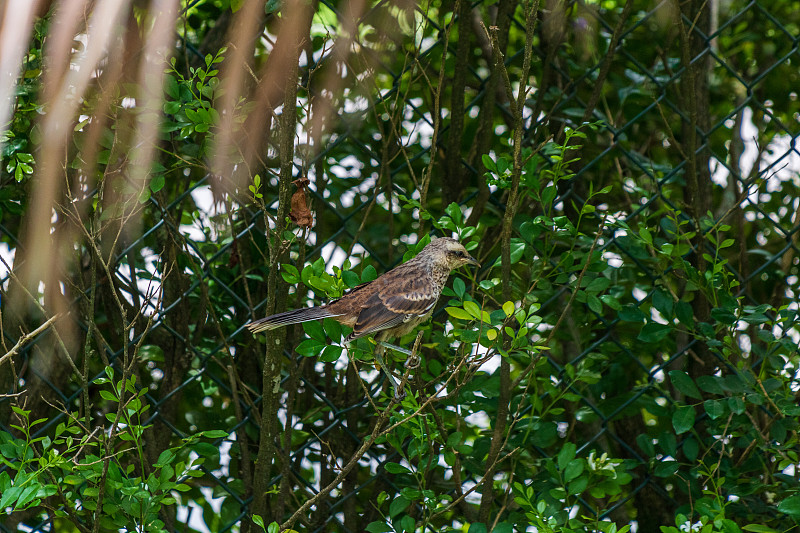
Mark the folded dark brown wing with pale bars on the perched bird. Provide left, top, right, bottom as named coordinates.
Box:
left=348, top=272, right=439, bottom=339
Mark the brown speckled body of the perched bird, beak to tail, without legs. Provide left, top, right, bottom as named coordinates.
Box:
left=247, top=237, right=478, bottom=342
